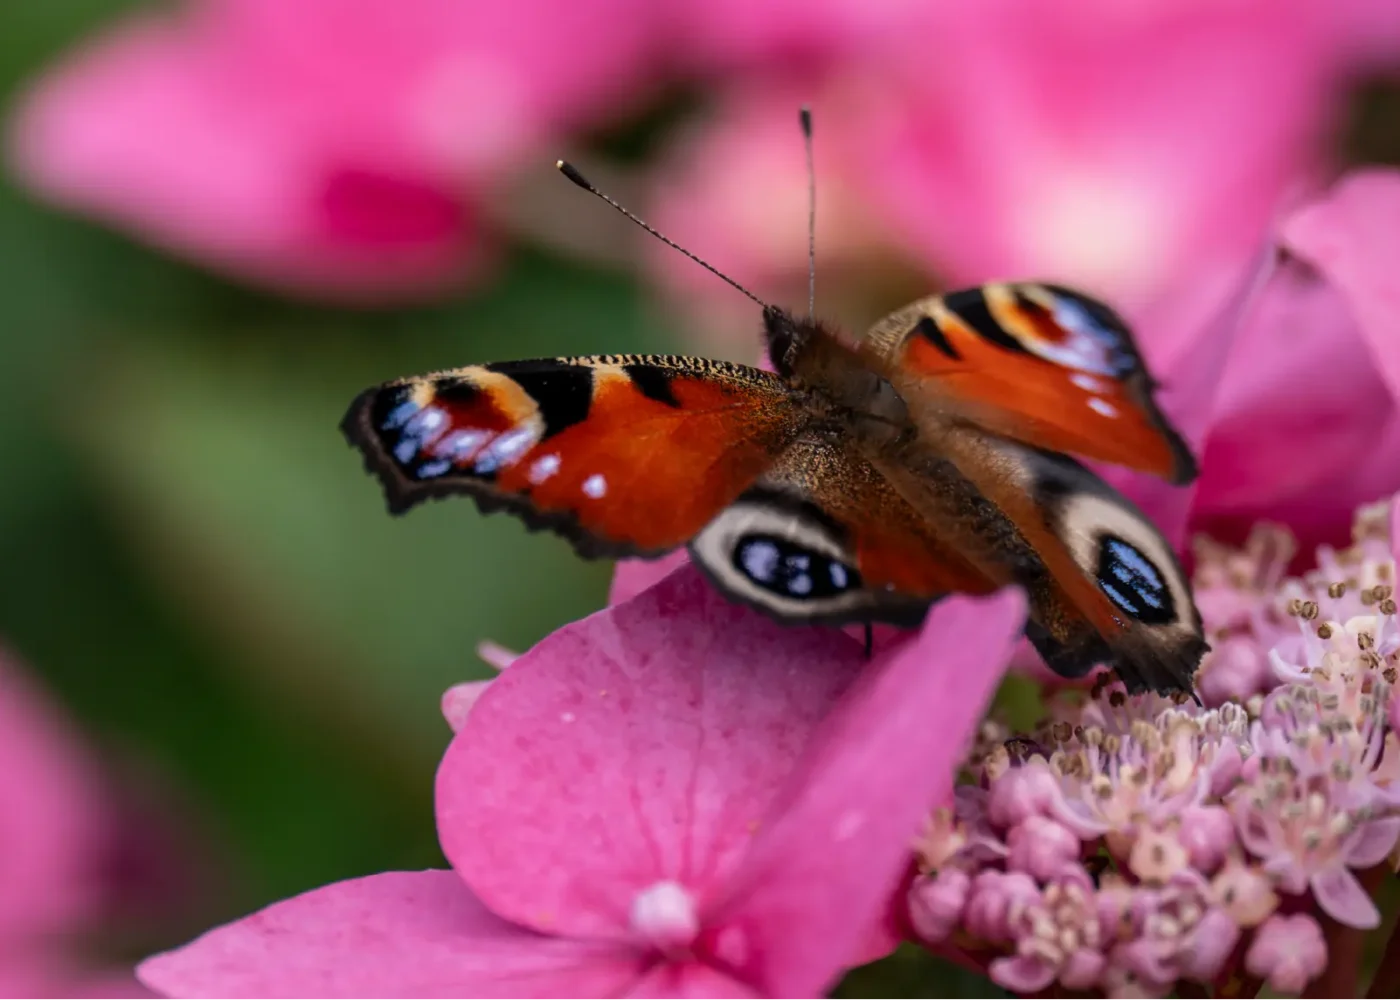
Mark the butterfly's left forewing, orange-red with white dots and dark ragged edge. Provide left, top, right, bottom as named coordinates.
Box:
left=342, top=354, right=804, bottom=556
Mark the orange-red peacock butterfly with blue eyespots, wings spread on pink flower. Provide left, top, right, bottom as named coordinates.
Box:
left=342, top=157, right=1208, bottom=692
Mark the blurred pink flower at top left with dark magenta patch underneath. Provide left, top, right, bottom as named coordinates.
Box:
left=10, top=0, right=652, bottom=300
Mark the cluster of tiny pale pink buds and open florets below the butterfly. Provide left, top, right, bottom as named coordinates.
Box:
left=907, top=495, right=1400, bottom=997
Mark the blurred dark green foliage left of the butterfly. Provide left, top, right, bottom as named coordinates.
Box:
left=0, top=0, right=688, bottom=947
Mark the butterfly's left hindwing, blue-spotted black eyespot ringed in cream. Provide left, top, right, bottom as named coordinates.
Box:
left=690, top=434, right=995, bottom=626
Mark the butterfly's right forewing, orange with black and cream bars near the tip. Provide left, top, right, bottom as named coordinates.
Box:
left=861, top=283, right=1196, bottom=483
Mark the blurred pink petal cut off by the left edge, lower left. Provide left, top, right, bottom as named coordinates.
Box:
left=0, top=650, right=105, bottom=947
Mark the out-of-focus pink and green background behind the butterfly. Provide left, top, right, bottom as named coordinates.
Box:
left=8, top=0, right=1400, bottom=991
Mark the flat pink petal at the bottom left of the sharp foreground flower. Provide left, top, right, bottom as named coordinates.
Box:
left=137, top=871, right=644, bottom=1000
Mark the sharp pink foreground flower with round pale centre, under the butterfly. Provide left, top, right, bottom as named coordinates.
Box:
left=140, top=569, right=1025, bottom=1000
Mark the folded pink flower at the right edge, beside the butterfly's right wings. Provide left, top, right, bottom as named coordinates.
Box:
left=1187, top=169, right=1400, bottom=545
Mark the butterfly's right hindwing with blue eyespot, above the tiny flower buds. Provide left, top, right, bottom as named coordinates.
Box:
left=871, top=424, right=1208, bottom=692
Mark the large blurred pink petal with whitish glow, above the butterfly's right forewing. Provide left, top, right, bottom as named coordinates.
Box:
left=861, top=0, right=1337, bottom=338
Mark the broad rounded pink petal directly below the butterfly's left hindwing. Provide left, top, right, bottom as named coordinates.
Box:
left=437, top=567, right=862, bottom=937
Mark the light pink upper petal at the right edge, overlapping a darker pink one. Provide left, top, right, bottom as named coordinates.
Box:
left=1284, top=169, right=1400, bottom=399
